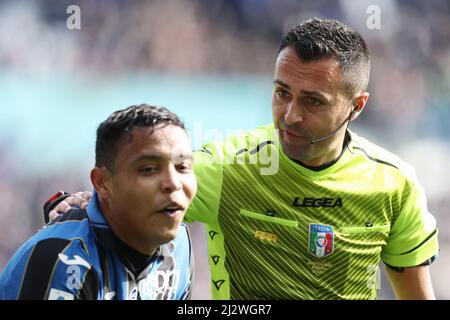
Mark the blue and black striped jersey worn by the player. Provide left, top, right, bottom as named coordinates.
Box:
left=0, top=193, right=193, bottom=300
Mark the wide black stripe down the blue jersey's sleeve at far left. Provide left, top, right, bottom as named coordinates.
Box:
left=18, top=238, right=70, bottom=300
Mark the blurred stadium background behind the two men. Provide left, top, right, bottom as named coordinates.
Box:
left=0, top=0, right=450, bottom=299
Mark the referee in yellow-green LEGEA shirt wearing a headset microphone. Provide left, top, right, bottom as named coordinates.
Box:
left=44, top=18, right=439, bottom=299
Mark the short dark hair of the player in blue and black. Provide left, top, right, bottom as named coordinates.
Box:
left=95, top=104, right=186, bottom=172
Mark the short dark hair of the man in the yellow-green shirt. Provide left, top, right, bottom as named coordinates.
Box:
left=278, top=18, right=370, bottom=97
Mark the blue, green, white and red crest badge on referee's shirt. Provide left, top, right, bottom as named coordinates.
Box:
left=308, top=223, right=334, bottom=258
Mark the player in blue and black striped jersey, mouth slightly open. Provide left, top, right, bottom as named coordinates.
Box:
left=0, top=105, right=196, bottom=300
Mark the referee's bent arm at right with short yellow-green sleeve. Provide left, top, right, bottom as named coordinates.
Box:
left=381, top=172, right=439, bottom=300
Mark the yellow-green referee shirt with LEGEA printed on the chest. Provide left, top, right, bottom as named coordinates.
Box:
left=186, top=124, right=438, bottom=299
